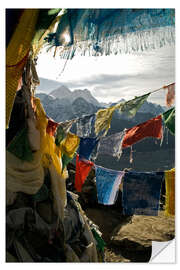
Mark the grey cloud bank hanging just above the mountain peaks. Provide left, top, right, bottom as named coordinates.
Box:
left=59, top=67, right=174, bottom=103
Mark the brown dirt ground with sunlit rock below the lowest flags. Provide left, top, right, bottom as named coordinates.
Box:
left=85, top=206, right=175, bottom=262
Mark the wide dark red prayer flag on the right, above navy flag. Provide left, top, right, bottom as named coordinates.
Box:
left=122, top=115, right=163, bottom=148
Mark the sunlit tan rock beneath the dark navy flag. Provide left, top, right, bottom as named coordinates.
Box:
left=111, top=211, right=175, bottom=247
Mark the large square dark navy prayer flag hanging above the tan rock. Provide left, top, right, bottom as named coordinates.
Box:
left=122, top=172, right=164, bottom=216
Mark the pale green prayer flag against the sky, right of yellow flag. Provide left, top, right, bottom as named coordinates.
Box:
left=117, top=93, right=151, bottom=117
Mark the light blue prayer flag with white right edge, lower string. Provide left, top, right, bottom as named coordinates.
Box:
left=95, top=165, right=124, bottom=205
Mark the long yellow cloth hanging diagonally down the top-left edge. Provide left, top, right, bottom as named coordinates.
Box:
left=6, top=9, right=39, bottom=128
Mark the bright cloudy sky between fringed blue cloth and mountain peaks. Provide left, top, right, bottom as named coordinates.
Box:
left=37, top=45, right=175, bottom=105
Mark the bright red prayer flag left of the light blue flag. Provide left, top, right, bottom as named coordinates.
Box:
left=75, top=155, right=94, bottom=192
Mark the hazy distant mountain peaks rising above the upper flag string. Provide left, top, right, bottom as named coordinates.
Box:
left=36, top=79, right=165, bottom=122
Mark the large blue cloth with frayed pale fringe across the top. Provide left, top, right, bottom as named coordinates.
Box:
left=47, top=8, right=175, bottom=59
